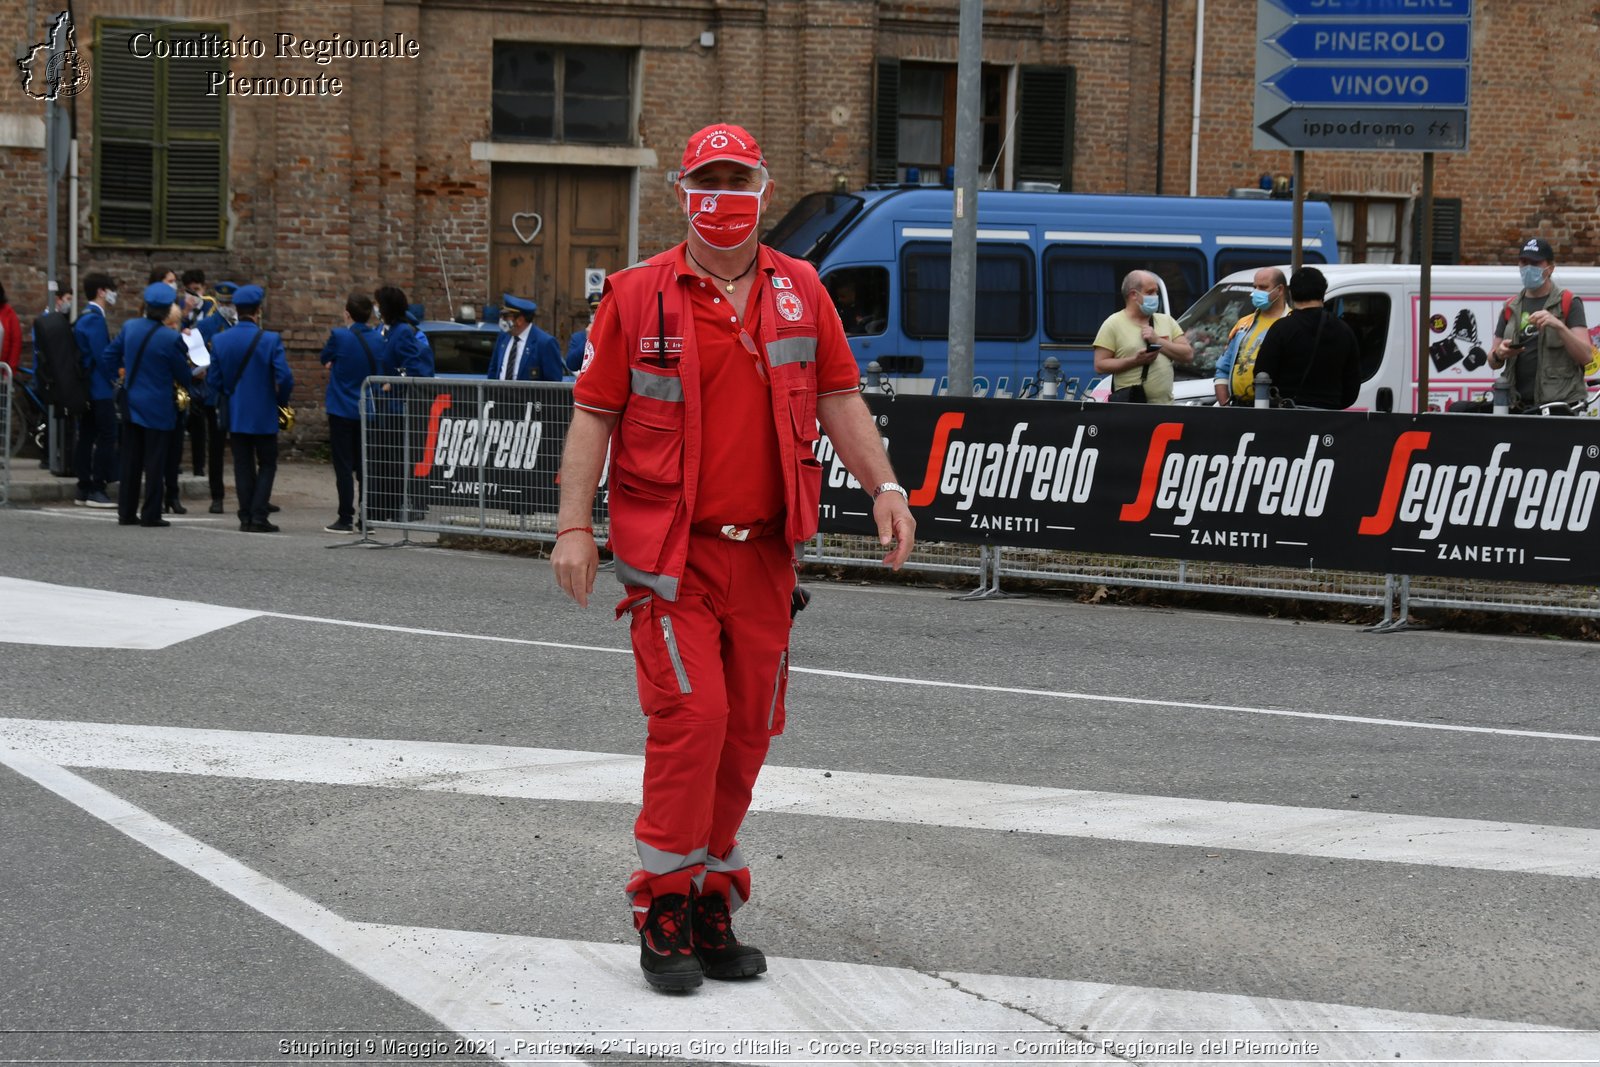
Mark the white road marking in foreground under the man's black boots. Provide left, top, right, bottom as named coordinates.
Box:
left=0, top=750, right=1595, bottom=1064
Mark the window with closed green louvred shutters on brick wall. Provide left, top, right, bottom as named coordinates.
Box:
left=93, top=19, right=227, bottom=248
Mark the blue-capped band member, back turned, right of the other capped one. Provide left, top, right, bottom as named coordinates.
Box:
left=211, top=285, right=294, bottom=533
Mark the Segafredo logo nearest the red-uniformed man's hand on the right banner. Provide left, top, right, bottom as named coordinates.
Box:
left=910, top=411, right=1099, bottom=512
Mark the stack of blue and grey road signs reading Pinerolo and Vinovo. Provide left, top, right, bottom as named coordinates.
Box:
left=1253, top=0, right=1472, bottom=152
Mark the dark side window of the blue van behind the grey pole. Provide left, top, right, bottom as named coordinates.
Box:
left=901, top=243, right=1034, bottom=341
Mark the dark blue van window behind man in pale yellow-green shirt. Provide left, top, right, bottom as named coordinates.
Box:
left=1045, top=245, right=1206, bottom=344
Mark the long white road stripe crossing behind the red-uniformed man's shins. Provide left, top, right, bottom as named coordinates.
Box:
left=0, top=718, right=1600, bottom=878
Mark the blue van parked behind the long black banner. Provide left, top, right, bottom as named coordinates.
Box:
left=765, top=187, right=1339, bottom=397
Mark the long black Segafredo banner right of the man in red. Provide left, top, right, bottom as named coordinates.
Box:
left=819, top=397, right=1600, bottom=584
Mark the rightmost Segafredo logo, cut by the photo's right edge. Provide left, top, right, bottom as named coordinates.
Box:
left=1360, top=430, right=1600, bottom=541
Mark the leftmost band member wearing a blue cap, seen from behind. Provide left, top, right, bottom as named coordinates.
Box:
left=101, top=282, right=194, bottom=526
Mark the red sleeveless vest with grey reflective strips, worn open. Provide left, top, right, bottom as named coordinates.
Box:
left=606, top=246, right=832, bottom=600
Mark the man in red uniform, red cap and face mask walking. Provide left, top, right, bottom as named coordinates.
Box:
left=550, top=123, right=915, bottom=990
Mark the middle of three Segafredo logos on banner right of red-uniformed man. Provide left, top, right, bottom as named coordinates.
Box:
left=1122, top=422, right=1333, bottom=526
